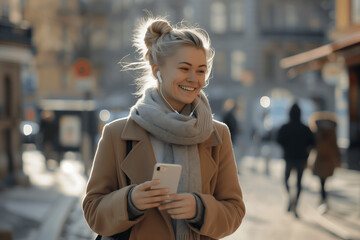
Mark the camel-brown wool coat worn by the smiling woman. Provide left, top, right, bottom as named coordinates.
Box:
left=83, top=119, right=245, bottom=240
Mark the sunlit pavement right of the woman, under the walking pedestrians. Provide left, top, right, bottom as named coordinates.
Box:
left=223, top=157, right=360, bottom=240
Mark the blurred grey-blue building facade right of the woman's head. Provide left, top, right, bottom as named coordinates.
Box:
left=184, top=0, right=334, bottom=138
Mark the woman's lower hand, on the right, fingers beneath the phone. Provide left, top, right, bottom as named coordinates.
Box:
left=159, top=193, right=196, bottom=219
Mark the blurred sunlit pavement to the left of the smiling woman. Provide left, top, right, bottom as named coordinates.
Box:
left=0, top=148, right=90, bottom=240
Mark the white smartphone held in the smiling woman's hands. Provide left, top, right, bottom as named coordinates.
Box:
left=152, top=163, right=181, bottom=194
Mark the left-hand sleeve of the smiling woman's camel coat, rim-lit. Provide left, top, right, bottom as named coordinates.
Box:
left=83, top=125, right=143, bottom=236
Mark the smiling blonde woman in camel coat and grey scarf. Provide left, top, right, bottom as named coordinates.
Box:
left=83, top=16, right=245, bottom=240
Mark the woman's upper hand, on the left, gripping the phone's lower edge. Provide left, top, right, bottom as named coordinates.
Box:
left=131, top=179, right=169, bottom=211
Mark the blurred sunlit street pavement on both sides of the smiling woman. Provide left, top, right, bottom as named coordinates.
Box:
left=0, top=146, right=360, bottom=240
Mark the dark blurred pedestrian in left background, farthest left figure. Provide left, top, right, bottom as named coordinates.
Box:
left=40, top=110, right=59, bottom=163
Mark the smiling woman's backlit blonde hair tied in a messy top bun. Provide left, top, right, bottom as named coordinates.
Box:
left=124, top=17, right=215, bottom=96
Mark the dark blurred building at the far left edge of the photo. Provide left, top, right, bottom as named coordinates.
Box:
left=0, top=0, right=32, bottom=186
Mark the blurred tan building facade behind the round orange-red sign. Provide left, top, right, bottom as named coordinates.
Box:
left=24, top=0, right=107, bottom=99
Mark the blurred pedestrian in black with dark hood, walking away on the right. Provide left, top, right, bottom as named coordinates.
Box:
left=277, top=103, right=314, bottom=217
